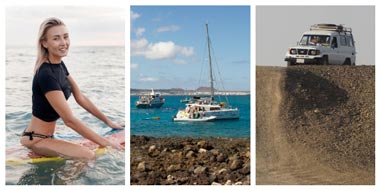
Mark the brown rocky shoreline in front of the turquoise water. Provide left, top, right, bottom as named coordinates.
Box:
left=130, top=135, right=251, bottom=185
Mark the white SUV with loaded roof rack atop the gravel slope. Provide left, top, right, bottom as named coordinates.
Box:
left=285, top=24, right=356, bottom=66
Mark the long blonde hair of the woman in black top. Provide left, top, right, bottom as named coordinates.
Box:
left=34, top=17, right=65, bottom=73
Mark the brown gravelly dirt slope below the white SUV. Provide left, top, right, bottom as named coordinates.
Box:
left=256, top=66, right=375, bottom=185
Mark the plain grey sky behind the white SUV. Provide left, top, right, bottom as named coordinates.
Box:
left=256, top=6, right=375, bottom=66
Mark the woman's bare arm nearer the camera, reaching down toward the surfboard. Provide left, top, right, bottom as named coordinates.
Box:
left=45, top=90, right=124, bottom=149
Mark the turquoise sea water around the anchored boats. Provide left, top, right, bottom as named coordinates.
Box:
left=130, top=95, right=250, bottom=138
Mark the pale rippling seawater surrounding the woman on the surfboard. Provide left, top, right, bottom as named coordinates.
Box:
left=5, top=47, right=125, bottom=185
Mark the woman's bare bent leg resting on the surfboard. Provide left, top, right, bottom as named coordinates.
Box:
left=29, top=138, right=96, bottom=160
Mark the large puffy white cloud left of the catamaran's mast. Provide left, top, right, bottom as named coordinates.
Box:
left=131, top=38, right=194, bottom=60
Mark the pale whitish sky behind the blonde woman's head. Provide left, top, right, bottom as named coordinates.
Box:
left=5, top=6, right=126, bottom=46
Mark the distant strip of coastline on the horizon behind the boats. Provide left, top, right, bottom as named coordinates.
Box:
left=131, top=87, right=251, bottom=96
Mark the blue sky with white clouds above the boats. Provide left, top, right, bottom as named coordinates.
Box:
left=131, top=6, right=250, bottom=91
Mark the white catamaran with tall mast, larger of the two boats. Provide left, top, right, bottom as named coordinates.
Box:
left=173, top=24, right=240, bottom=121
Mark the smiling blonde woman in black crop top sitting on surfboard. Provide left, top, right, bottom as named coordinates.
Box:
left=21, top=18, right=124, bottom=159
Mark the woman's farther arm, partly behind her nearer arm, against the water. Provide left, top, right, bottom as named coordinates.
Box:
left=67, top=75, right=124, bottom=129
